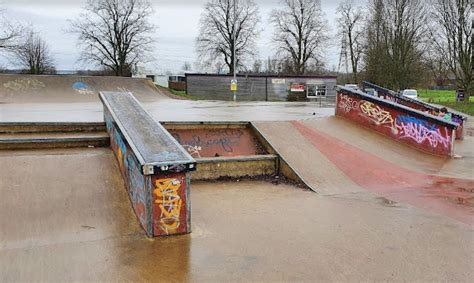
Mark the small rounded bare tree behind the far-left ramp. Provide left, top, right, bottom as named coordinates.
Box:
left=11, top=30, right=55, bottom=75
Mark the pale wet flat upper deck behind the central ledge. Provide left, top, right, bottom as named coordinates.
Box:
left=0, top=99, right=334, bottom=122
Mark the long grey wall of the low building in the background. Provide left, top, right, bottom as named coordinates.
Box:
left=186, top=74, right=336, bottom=101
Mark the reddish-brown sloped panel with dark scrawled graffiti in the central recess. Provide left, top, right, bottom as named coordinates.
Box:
left=169, top=128, right=264, bottom=158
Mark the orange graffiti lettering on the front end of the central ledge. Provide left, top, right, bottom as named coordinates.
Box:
left=153, top=178, right=183, bottom=234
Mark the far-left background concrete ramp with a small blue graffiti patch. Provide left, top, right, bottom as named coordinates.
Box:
left=0, top=75, right=167, bottom=103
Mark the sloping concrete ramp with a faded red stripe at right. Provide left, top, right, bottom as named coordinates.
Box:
left=255, top=117, right=474, bottom=225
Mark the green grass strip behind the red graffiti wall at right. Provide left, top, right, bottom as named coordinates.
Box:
left=417, top=89, right=474, bottom=115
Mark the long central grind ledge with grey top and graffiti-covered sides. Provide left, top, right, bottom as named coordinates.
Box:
left=100, top=92, right=196, bottom=237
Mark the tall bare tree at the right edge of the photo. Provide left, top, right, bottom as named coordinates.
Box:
left=432, top=0, right=474, bottom=101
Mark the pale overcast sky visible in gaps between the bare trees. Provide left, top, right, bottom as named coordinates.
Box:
left=0, top=0, right=366, bottom=73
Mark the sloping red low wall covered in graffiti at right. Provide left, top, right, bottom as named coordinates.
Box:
left=336, top=87, right=457, bottom=156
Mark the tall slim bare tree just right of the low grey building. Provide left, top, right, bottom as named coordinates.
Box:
left=337, top=0, right=365, bottom=83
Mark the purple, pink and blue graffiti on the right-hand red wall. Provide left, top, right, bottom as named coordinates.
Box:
left=396, top=116, right=451, bottom=148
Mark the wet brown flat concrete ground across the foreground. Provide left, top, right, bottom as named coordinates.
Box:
left=0, top=149, right=474, bottom=282
